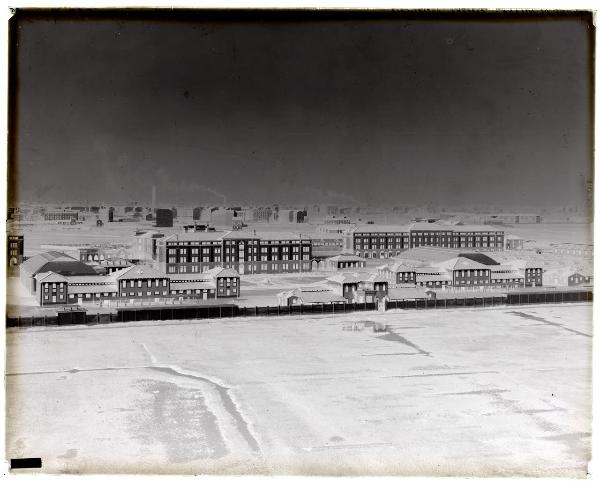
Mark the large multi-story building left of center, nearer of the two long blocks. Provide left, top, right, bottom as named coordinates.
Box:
left=155, top=230, right=312, bottom=274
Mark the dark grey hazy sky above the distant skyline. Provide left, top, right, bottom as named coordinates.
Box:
left=11, top=11, right=593, bottom=207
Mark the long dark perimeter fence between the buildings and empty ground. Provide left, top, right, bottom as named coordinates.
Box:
left=6, top=290, right=593, bottom=327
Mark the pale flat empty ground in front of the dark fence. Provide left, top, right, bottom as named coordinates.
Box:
left=6, top=304, right=592, bottom=476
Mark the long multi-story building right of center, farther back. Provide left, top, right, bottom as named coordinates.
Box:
left=344, top=222, right=504, bottom=258
